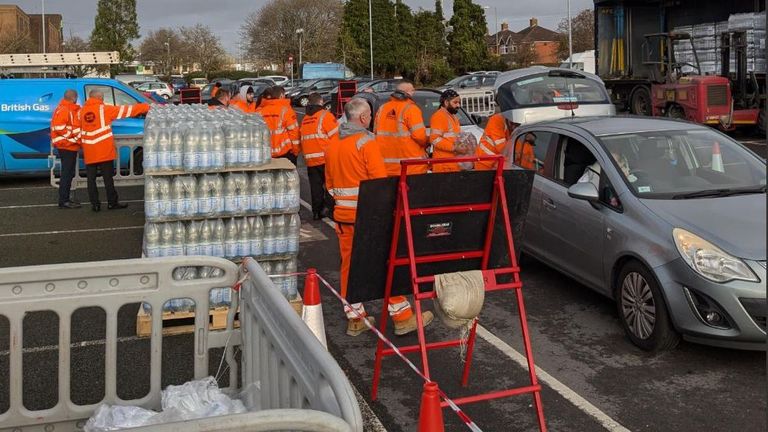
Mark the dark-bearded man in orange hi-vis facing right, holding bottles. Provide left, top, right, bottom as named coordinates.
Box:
left=429, top=89, right=468, bottom=172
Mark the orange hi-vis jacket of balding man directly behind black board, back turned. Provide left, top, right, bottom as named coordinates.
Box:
left=374, top=93, right=427, bottom=176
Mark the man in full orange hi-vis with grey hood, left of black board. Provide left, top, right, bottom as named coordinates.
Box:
left=325, top=98, right=433, bottom=336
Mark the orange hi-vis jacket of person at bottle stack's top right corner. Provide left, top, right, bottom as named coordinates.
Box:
left=258, top=99, right=300, bottom=157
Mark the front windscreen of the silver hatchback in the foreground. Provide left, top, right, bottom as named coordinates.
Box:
left=599, top=129, right=766, bottom=199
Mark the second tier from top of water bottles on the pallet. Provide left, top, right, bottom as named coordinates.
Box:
left=144, top=169, right=299, bottom=222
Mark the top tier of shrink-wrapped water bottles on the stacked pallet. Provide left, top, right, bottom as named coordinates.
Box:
left=143, top=105, right=272, bottom=174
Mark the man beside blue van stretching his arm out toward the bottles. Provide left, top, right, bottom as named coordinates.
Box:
left=78, top=90, right=149, bottom=212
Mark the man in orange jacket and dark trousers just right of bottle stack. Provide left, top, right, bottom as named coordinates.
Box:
left=299, top=93, right=339, bottom=220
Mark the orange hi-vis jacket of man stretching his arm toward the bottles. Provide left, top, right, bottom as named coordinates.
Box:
left=79, top=98, right=149, bottom=165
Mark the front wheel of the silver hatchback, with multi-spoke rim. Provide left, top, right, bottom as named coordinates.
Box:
left=616, top=261, right=680, bottom=352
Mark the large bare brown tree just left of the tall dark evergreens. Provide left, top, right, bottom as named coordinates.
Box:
left=241, top=0, right=342, bottom=73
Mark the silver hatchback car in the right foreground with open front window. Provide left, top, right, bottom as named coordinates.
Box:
left=505, top=117, right=766, bottom=351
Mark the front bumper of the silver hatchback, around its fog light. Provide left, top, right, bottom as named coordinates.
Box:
left=654, top=258, right=766, bottom=350
